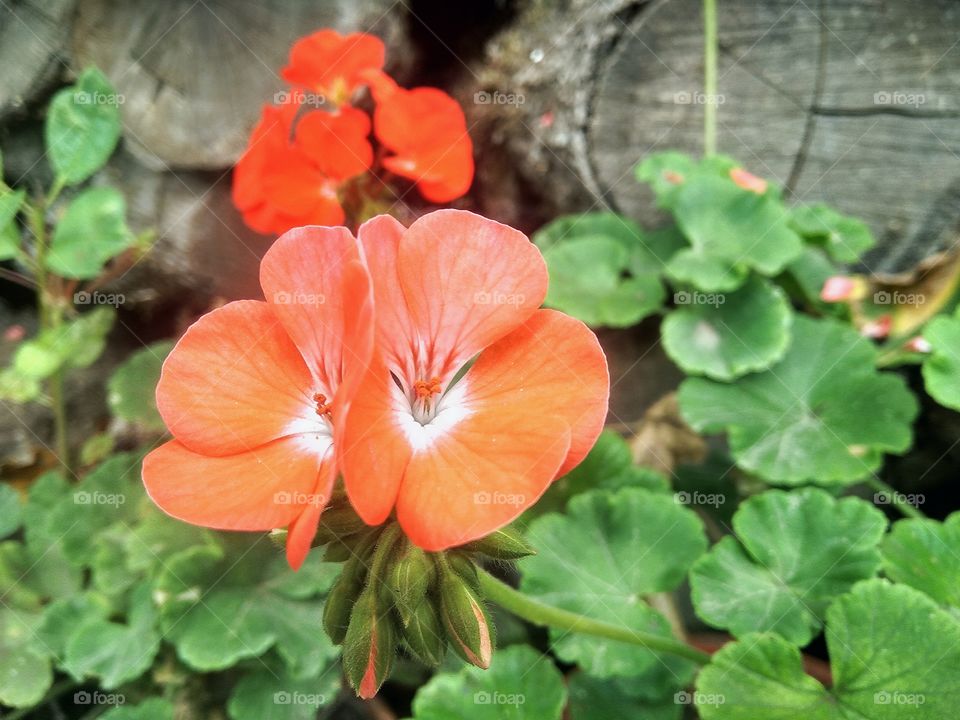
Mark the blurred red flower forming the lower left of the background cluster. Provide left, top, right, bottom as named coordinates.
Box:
left=233, top=102, right=373, bottom=233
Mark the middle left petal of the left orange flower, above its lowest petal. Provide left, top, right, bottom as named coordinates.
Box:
left=157, top=300, right=316, bottom=455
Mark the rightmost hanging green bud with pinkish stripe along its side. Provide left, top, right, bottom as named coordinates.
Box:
left=440, top=572, right=494, bottom=670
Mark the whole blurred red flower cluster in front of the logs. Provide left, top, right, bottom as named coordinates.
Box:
left=233, top=30, right=474, bottom=233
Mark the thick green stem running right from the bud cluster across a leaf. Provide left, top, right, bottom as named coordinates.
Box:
left=480, top=570, right=710, bottom=665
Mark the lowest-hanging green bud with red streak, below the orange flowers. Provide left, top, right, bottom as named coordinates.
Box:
left=343, top=588, right=397, bottom=698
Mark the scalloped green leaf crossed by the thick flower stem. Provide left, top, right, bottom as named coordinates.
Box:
left=521, top=488, right=706, bottom=677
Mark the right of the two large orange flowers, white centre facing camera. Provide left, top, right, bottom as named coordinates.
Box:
left=340, top=210, right=609, bottom=550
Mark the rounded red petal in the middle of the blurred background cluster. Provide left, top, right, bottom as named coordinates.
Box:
left=296, top=106, right=373, bottom=180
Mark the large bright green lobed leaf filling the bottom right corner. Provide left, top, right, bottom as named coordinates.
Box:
left=696, top=580, right=960, bottom=720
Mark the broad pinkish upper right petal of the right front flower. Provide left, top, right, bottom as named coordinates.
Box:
left=398, top=210, right=547, bottom=376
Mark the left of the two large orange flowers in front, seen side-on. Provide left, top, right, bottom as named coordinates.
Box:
left=143, top=227, right=374, bottom=568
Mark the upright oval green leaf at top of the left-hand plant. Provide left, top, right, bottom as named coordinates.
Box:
left=44, top=67, right=120, bottom=185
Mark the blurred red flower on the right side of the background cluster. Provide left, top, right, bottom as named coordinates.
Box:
left=364, top=73, right=474, bottom=203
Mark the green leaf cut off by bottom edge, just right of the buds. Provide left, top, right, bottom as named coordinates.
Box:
left=413, top=645, right=567, bottom=720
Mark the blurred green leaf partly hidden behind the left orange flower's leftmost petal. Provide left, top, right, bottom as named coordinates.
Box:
left=107, top=341, right=173, bottom=432
